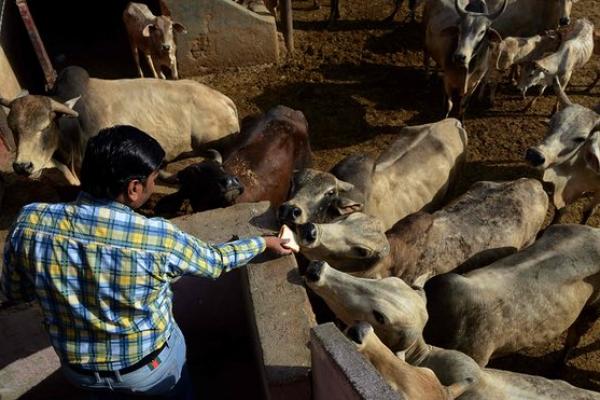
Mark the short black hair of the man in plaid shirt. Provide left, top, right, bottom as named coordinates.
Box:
left=81, top=125, right=165, bottom=199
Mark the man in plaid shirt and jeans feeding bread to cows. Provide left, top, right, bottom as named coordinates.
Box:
left=1, top=126, right=291, bottom=398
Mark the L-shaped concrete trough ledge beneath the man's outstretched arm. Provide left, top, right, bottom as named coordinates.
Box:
left=173, top=202, right=316, bottom=400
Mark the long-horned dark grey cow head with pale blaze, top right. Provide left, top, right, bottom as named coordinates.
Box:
left=447, top=0, right=507, bottom=68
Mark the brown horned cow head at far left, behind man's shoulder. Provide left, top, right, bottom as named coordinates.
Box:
left=0, top=95, right=79, bottom=178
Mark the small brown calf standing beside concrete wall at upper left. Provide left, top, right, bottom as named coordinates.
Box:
left=123, top=2, right=187, bottom=79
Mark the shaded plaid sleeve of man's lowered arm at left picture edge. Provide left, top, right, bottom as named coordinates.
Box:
left=0, top=230, right=35, bottom=301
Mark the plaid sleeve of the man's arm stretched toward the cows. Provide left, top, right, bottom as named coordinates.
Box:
left=167, top=230, right=266, bottom=279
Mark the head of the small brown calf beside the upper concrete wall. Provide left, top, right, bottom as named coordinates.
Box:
left=142, top=15, right=187, bottom=79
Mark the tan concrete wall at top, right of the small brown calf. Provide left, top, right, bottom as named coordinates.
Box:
left=164, top=0, right=279, bottom=77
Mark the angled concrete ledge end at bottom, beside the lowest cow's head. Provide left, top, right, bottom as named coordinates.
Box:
left=310, top=323, right=404, bottom=400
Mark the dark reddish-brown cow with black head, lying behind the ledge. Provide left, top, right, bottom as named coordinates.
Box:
left=157, top=106, right=311, bottom=213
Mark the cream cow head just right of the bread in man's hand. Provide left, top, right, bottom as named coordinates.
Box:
left=297, top=212, right=390, bottom=272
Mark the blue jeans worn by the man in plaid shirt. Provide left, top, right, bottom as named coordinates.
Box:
left=62, top=324, right=194, bottom=400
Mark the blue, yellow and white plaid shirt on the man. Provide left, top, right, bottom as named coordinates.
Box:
left=1, top=193, right=265, bottom=370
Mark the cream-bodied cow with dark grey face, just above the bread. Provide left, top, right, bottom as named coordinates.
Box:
left=279, top=119, right=467, bottom=229
